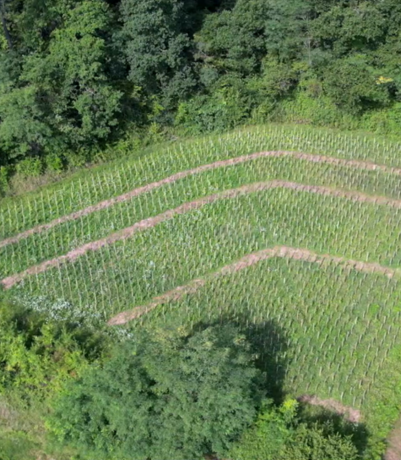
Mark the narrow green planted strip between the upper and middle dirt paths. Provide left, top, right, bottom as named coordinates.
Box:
left=0, top=157, right=401, bottom=278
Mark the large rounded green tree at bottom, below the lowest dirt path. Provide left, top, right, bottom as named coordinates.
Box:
left=49, top=326, right=262, bottom=460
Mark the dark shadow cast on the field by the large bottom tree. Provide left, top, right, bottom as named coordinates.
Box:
left=191, top=315, right=289, bottom=403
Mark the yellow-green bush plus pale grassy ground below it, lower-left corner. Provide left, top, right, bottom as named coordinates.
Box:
left=0, top=299, right=108, bottom=460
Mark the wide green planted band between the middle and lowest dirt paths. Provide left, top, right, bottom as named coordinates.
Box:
left=8, top=189, right=401, bottom=318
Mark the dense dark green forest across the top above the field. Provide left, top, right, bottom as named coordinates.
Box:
left=0, top=0, right=401, bottom=169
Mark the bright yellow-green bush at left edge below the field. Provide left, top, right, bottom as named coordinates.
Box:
left=0, top=302, right=105, bottom=405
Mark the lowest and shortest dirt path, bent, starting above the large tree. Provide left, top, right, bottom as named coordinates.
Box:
left=107, top=246, right=401, bottom=328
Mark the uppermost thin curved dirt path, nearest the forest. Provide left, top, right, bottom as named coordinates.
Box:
left=0, top=151, right=401, bottom=248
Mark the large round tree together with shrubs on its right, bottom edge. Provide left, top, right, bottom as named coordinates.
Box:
left=48, top=325, right=360, bottom=460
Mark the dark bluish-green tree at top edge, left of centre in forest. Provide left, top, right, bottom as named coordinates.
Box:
left=121, top=0, right=196, bottom=107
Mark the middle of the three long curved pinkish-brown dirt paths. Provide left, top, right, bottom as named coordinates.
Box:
left=1, top=180, right=401, bottom=289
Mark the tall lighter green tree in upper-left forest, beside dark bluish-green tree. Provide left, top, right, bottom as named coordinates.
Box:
left=36, top=0, right=122, bottom=147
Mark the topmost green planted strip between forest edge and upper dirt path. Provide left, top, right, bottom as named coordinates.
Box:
left=0, top=125, right=401, bottom=238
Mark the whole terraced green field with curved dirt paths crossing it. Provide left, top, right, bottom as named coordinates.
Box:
left=0, top=126, right=401, bottom=458
